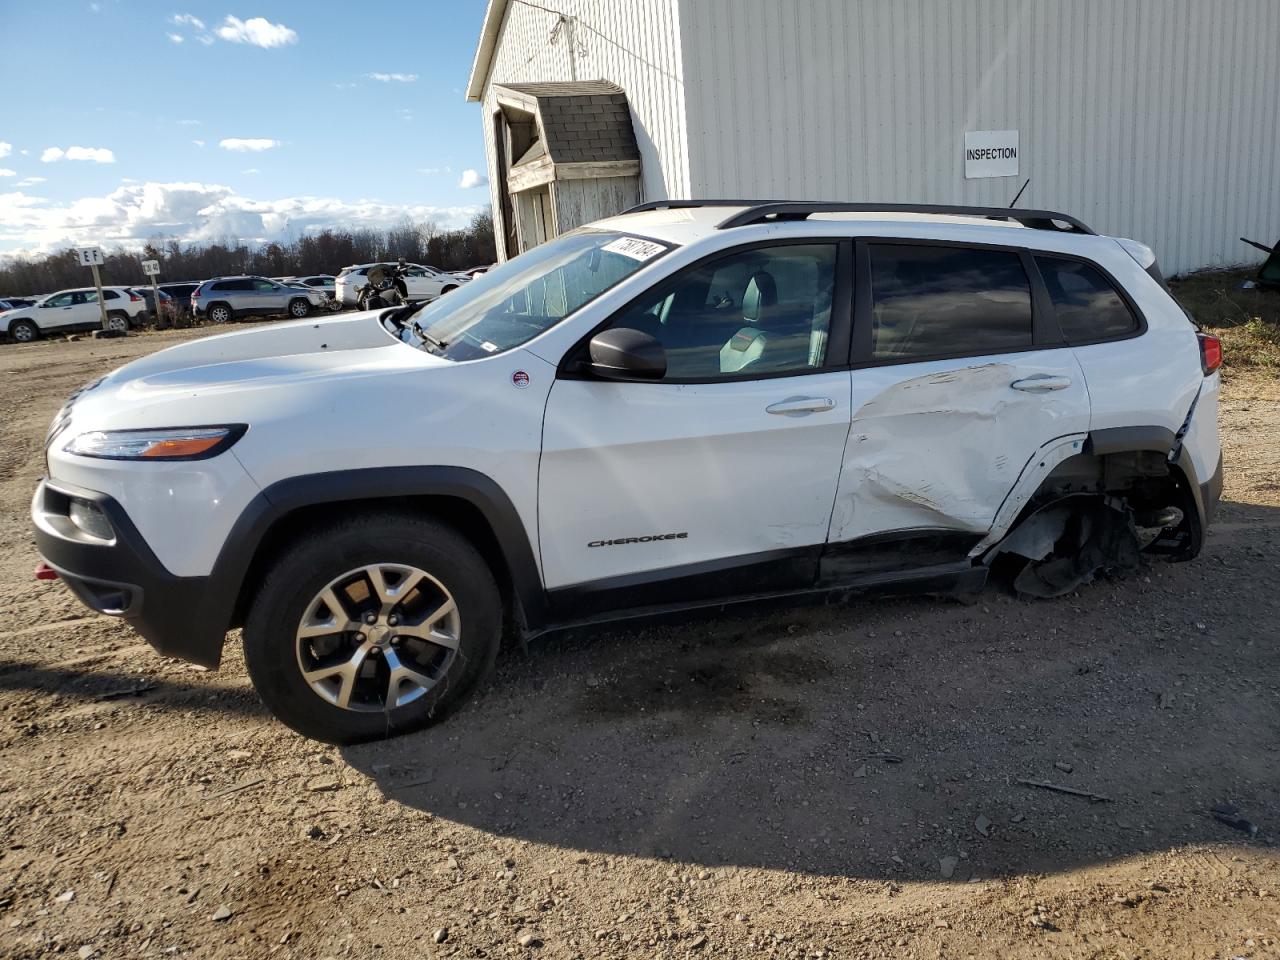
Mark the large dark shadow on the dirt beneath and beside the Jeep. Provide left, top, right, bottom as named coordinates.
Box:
left=344, top=504, right=1280, bottom=881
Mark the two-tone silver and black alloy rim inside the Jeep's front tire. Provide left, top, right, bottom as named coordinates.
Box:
left=294, top=563, right=462, bottom=713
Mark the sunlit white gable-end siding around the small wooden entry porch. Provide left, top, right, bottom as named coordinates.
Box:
left=484, top=0, right=690, bottom=207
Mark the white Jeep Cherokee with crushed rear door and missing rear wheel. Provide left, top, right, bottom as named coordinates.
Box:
left=32, top=201, right=1222, bottom=742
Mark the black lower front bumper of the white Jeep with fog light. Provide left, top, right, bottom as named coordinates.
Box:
left=31, top=480, right=230, bottom=667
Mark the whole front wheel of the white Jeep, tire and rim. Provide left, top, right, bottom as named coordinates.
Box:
left=244, top=513, right=503, bottom=744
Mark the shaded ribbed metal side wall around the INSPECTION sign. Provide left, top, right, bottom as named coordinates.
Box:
left=686, top=0, right=1280, bottom=273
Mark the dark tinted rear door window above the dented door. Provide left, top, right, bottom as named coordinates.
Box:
left=869, top=243, right=1032, bottom=361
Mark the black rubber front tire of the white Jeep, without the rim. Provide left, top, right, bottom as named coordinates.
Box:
left=244, top=513, right=503, bottom=744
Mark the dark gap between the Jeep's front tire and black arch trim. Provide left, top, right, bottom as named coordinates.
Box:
left=232, top=495, right=516, bottom=635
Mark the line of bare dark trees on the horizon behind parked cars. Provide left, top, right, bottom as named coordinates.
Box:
left=0, top=211, right=498, bottom=297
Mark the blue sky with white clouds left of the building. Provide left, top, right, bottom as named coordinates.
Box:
left=0, top=0, right=489, bottom=256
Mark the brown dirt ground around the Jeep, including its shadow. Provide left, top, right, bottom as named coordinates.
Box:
left=0, top=325, right=1280, bottom=960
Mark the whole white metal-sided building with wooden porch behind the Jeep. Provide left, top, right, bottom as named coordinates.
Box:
left=467, top=0, right=1280, bottom=274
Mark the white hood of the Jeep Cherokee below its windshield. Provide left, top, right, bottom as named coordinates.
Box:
left=74, top=311, right=452, bottom=429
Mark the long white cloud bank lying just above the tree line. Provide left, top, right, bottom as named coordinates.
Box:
left=0, top=182, right=480, bottom=256
